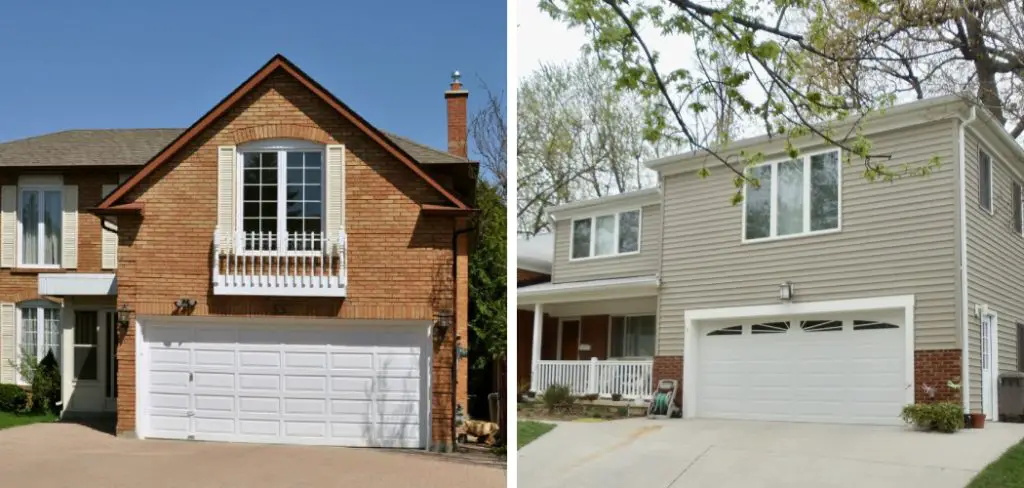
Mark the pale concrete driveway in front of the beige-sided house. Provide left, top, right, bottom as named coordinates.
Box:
left=518, top=419, right=1024, bottom=488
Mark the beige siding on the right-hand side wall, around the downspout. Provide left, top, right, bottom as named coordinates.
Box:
left=965, top=130, right=1024, bottom=411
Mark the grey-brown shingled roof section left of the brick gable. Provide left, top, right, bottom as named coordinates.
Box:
left=0, top=129, right=181, bottom=167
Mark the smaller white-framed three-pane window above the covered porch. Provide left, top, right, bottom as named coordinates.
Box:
left=569, top=209, right=640, bottom=260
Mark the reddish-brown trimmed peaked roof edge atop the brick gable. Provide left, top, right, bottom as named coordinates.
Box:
left=96, top=54, right=469, bottom=211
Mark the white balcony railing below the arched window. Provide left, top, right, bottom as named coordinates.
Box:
left=213, top=231, right=347, bottom=297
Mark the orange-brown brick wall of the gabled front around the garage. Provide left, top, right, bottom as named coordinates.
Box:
left=111, top=72, right=468, bottom=445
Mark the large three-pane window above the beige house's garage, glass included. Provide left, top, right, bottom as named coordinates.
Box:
left=742, top=149, right=843, bottom=241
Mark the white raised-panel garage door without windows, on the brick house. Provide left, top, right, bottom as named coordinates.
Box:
left=137, top=322, right=430, bottom=447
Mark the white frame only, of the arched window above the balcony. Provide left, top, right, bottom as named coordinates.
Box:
left=233, top=139, right=327, bottom=257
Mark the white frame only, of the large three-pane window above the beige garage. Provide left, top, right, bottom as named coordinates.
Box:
left=739, top=147, right=843, bottom=243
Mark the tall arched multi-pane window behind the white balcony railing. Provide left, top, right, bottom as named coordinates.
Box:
left=238, top=140, right=325, bottom=253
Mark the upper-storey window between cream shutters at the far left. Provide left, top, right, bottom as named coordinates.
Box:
left=17, top=186, right=63, bottom=268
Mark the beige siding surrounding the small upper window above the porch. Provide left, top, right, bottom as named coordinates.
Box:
left=551, top=205, right=662, bottom=283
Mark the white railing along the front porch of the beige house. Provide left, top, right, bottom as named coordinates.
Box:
left=531, top=358, right=654, bottom=399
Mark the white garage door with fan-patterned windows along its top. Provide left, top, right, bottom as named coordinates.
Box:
left=695, top=315, right=912, bottom=424
